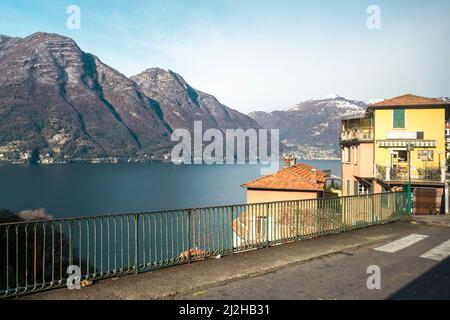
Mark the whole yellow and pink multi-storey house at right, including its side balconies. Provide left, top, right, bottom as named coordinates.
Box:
left=341, top=94, right=450, bottom=213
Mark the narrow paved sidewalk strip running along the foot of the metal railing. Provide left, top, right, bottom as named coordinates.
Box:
left=20, top=221, right=430, bottom=300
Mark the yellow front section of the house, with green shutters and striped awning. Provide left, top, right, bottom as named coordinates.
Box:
left=368, top=95, right=448, bottom=185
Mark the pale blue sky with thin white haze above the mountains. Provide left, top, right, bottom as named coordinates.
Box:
left=0, top=0, right=450, bottom=113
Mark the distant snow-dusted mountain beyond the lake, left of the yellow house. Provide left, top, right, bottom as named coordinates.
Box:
left=249, top=95, right=367, bottom=155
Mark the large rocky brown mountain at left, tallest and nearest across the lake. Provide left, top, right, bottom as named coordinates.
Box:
left=0, top=33, right=170, bottom=159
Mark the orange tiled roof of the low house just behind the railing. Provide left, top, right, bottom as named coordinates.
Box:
left=241, top=163, right=327, bottom=191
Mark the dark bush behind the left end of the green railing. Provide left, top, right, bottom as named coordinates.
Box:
left=0, top=209, right=84, bottom=296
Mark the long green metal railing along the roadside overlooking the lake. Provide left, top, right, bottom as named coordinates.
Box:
left=0, top=192, right=408, bottom=298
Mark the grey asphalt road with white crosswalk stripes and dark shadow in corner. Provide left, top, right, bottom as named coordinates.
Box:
left=175, top=224, right=450, bottom=300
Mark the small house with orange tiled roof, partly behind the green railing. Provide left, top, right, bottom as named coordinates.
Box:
left=233, top=164, right=329, bottom=243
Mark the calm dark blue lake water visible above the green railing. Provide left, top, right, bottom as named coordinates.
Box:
left=0, top=160, right=341, bottom=218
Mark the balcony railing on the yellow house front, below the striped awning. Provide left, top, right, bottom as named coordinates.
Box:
left=376, top=165, right=445, bottom=182
